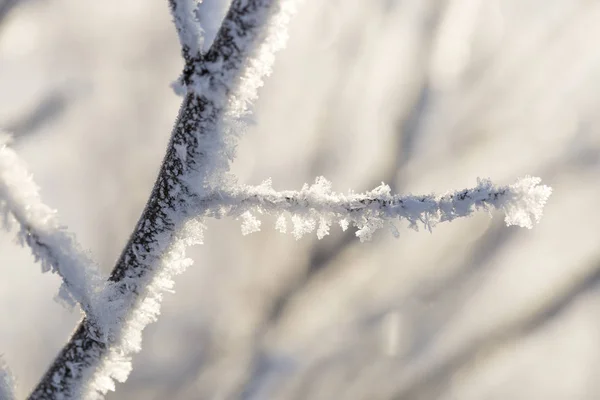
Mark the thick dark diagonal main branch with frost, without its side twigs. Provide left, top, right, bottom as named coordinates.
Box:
left=30, top=0, right=296, bottom=399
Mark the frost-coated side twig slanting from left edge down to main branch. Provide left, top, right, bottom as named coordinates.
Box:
left=0, top=133, right=103, bottom=314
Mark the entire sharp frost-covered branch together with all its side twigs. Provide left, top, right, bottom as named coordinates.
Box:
left=0, top=0, right=551, bottom=399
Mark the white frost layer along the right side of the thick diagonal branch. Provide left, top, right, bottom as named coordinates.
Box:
left=68, top=0, right=296, bottom=399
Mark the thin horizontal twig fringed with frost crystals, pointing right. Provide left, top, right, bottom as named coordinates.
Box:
left=193, top=176, right=552, bottom=241
